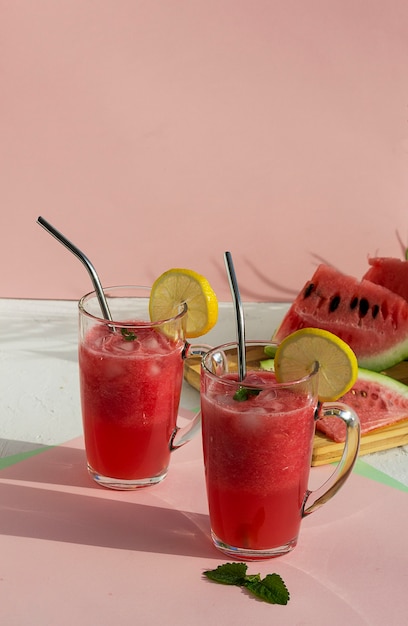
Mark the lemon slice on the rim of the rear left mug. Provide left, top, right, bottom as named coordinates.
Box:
left=149, top=268, right=218, bottom=337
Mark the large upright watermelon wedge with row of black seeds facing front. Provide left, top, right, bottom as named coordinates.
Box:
left=273, top=264, right=408, bottom=371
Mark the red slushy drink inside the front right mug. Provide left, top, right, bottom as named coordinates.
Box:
left=201, top=371, right=316, bottom=558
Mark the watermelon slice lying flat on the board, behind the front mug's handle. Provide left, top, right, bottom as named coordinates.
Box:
left=316, top=370, right=408, bottom=442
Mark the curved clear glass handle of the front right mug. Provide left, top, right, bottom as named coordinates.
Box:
left=302, top=402, right=360, bottom=517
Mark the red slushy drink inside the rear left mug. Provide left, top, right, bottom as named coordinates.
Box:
left=79, top=322, right=184, bottom=488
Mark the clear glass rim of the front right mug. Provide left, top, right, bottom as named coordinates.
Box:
left=201, top=340, right=319, bottom=389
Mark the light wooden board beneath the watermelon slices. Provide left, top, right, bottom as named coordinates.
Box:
left=184, top=357, right=408, bottom=466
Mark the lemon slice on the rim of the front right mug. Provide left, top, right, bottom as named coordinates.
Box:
left=275, top=328, right=358, bottom=402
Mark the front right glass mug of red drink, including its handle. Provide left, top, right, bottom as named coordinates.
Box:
left=201, top=341, right=360, bottom=560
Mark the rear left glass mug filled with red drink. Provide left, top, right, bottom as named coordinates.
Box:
left=78, top=286, right=208, bottom=489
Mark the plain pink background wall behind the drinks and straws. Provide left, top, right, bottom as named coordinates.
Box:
left=0, top=0, right=408, bottom=301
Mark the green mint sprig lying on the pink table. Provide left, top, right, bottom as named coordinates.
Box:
left=204, top=563, right=290, bottom=604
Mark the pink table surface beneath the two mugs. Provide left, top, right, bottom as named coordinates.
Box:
left=0, top=428, right=408, bottom=626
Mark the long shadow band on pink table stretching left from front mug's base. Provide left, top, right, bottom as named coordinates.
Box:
left=0, top=483, right=219, bottom=558
